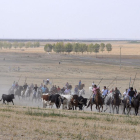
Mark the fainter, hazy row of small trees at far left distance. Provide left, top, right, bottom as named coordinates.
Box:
left=0, top=41, right=40, bottom=49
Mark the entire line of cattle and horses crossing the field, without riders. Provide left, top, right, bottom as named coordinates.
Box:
left=0, top=83, right=140, bottom=115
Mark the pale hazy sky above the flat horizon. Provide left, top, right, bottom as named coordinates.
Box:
left=0, top=0, right=140, bottom=39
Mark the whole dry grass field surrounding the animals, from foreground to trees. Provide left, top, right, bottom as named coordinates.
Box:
left=0, top=42, right=140, bottom=140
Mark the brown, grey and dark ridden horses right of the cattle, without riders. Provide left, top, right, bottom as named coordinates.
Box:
left=87, top=88, right=140, bottom=115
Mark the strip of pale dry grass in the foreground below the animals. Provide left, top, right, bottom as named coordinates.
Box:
left=0, top=105, right=140, bottom=140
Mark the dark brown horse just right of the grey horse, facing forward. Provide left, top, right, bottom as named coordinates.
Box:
left=112, top=91, right=121, bottom=114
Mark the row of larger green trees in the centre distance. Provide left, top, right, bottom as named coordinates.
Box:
left=44, top=42, right=112, bottom=54
